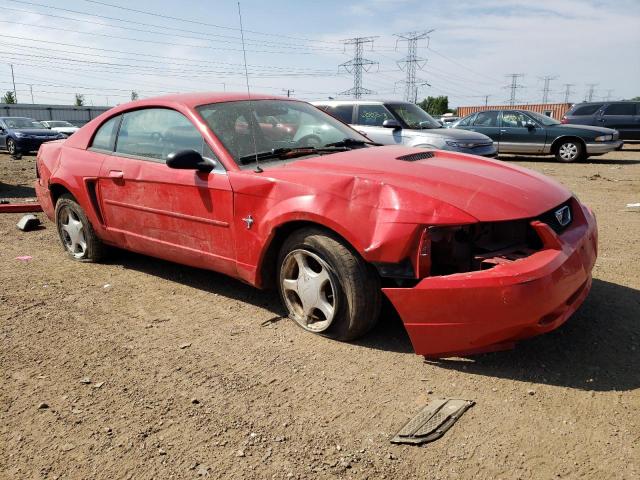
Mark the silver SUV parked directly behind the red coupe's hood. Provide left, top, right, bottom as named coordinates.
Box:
left=311, top=100, right=496, bottom=157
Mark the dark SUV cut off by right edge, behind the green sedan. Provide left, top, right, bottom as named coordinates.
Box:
left=562, top=102, right=640, bottom=140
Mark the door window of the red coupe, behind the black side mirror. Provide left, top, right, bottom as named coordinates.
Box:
left=116, top=108, right=206, bottom=161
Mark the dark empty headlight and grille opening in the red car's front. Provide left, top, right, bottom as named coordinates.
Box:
left=429, top=220, right=542, bottom=275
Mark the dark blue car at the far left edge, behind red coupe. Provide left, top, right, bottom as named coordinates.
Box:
left=0, top=117, right=65, bottom=155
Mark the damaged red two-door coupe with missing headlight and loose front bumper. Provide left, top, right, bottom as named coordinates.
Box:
left=36, top=93, right=597, bottom=356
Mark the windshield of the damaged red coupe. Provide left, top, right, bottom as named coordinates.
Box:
left=197, top=100, right=369, bottom=167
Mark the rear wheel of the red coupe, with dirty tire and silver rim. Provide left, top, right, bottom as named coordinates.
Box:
left=56, top=194, right=105, bottom=262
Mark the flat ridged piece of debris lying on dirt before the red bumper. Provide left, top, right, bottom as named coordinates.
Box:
left=391, top=398, right=475, bottom=445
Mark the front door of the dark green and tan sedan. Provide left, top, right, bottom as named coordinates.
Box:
left=498, top=110, right=547, bottom=153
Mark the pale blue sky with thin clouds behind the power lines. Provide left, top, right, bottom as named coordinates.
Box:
left=0, top=0, right=640, bottom=107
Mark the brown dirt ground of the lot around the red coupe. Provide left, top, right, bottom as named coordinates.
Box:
left=0, top=145, right=640, bottom=479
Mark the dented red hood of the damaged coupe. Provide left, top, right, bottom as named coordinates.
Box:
left=265, top=146, right=571, bottom=222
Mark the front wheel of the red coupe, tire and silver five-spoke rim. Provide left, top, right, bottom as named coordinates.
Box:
left=277, top=228, right=381, bottom=341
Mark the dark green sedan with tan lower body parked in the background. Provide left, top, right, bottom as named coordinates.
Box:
left=454, top=110, right=622, bottom=162
